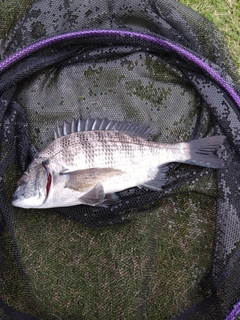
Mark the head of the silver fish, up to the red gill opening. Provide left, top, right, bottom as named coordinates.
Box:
left=12, top=158, right=52, bottom=208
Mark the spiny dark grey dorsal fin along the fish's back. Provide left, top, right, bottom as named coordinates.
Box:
left=54, top=118, right=157, bottom=139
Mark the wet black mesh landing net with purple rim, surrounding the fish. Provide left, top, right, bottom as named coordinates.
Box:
left=0, top=0, right=240, bottom=320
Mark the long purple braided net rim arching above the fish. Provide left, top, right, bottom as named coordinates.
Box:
left=0, top=30, right=240, bottom=107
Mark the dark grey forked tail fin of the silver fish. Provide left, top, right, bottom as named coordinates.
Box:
left=186, top=136, right=226, bottom=168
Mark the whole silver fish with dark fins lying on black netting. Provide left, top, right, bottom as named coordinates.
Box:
left=12, top=118, right=225, bottom=209
